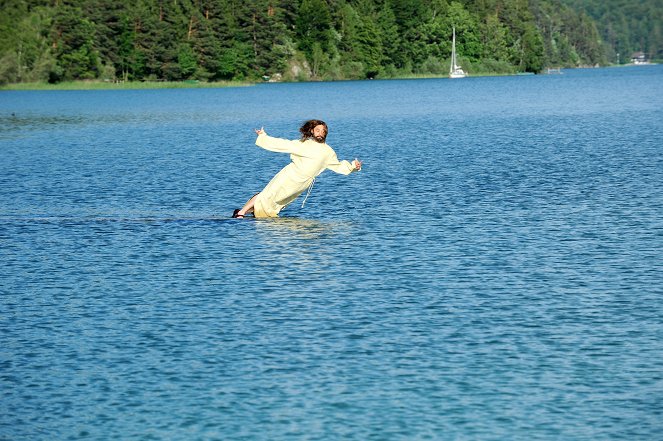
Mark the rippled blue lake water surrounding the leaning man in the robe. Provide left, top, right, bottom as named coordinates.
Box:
left=0, top=66, right=663, bottom=441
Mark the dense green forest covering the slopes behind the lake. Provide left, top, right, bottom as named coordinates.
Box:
left=0, top=0, right=662, bottom=84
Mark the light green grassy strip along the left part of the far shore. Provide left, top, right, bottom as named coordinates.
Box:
left=0, top=81, right=251, bottom=90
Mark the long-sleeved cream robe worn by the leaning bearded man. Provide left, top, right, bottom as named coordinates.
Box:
left=253, top=133, right=355, bottom=217
